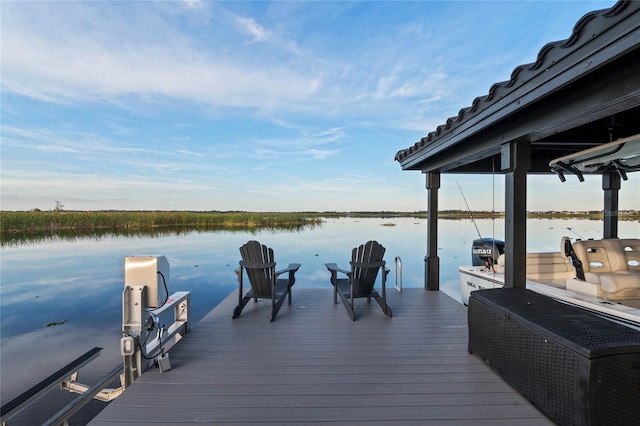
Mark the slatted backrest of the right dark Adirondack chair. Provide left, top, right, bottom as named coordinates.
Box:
left=351, top=241, right=386, bottom=297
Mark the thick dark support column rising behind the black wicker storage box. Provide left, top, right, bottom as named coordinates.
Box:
left=501, top=141, right=531, bottom=288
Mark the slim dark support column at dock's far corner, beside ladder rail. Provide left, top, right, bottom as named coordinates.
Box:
left=424, top=172, right=440, bottom=290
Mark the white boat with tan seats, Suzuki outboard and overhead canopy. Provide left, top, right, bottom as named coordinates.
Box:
left=459, top=135, right=640, bottom=329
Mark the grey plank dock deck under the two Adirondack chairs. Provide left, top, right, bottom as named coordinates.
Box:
left=90, top=287, right=552, bottom=426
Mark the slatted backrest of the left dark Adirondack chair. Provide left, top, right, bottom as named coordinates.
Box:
left=240, top=241, right=276, bottom=297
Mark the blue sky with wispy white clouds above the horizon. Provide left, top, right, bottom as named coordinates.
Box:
left=0, top=0, right=640, bottom=211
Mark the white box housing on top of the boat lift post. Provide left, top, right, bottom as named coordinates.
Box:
left=124, top=255, right=169, bottom=308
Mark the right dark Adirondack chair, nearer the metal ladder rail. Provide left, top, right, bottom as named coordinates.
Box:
left=325, top=241, right=392, bottom=321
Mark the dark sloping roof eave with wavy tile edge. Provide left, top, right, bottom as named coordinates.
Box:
left=395, top=1, right=640, bottom=171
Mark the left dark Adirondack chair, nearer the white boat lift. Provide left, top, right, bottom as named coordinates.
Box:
left=233, top=241, right=300, bottom=322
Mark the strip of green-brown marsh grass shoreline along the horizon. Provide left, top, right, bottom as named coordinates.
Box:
left=0, top=210, right=640, bottom=234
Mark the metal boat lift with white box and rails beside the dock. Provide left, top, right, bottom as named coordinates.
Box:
left=0, top=256, right=191, bottom=426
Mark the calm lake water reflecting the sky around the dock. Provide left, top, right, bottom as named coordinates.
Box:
left=0, top=218, right=640, bottom=425
